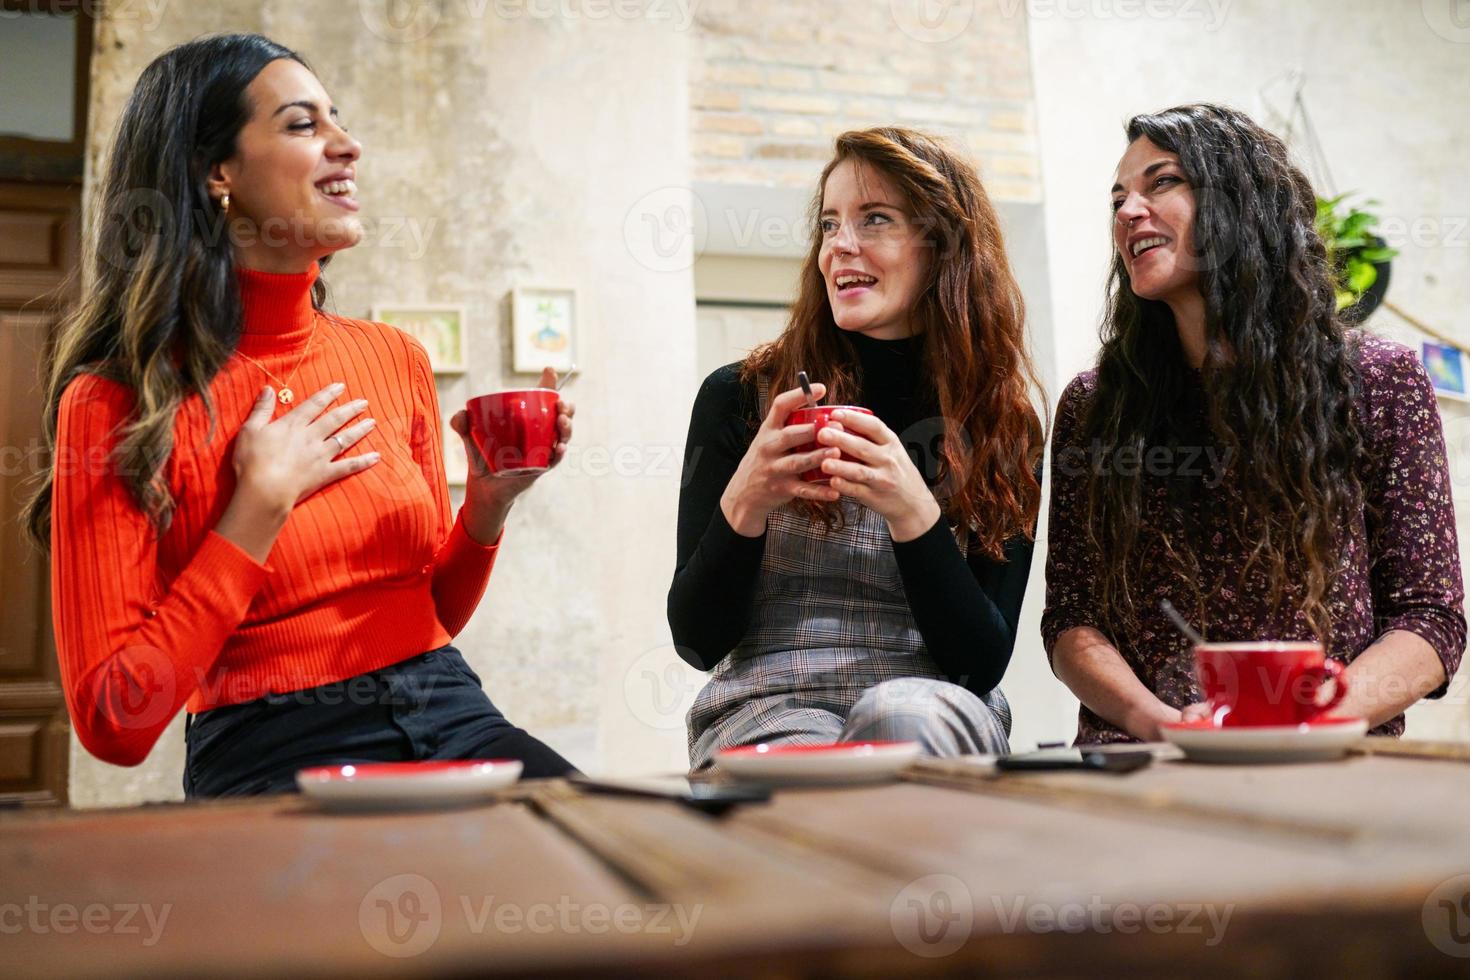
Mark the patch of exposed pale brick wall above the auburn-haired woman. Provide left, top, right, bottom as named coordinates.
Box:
left=689, top=0, right=1041, bottom=201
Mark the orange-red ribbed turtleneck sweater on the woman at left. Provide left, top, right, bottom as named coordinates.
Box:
left=51, top=266, right=498, bottom=765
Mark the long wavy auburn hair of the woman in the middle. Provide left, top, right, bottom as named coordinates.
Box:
left=741, top=128, right=1045, bottom=558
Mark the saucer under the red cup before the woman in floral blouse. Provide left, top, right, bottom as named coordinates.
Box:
left=1161, top=716, right=1369, bottom=764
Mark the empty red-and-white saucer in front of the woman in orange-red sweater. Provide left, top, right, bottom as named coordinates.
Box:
left=295, top=758, right=522, bottom=810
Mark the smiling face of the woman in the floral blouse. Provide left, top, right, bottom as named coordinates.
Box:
left=1113, top=137, right=1200, bottom=303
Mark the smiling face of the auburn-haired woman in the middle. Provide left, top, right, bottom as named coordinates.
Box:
left=817, top=159, right=931, bottom=341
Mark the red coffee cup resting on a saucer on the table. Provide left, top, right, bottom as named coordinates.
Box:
left=1195, top=641, right=1348, bottom=729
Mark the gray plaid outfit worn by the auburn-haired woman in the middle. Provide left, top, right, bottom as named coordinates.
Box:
left=688, top=379, right=1010, bottom=768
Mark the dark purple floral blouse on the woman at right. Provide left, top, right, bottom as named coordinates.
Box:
left=1041, top=334, right=1466, bottom=745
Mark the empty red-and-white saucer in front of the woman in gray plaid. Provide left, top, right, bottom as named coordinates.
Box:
left=714, top=742, right=919, bottom=786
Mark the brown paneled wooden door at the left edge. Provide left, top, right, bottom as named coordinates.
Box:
left=0, top=182, right=81, bottom=805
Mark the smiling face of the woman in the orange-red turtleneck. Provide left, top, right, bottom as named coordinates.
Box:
left=209, top=59, right=363, bottom=272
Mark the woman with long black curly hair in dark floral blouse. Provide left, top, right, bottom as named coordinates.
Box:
left=1042, top=104, right=1466, bottom=743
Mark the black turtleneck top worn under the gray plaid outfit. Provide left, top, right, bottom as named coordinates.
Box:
left=669, top=334, right=1032, bottom=695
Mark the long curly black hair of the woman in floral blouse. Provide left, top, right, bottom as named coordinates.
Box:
left=1082, top=104, right=1364, bottom=641
